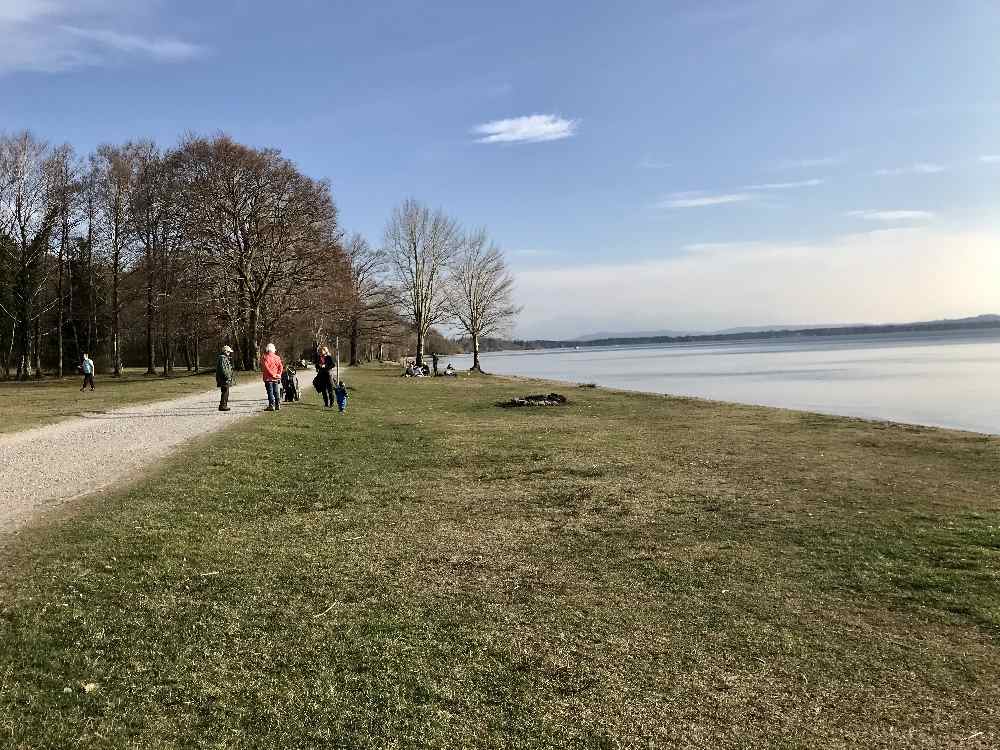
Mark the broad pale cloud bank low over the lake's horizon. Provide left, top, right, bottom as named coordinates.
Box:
left=516, top=227, right=1000, bottom=338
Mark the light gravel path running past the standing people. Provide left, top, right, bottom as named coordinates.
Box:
left=0, top=382, right=267, bottom=532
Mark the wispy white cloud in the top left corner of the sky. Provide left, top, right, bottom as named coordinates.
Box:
left=0, top=0, right=204, bottom=74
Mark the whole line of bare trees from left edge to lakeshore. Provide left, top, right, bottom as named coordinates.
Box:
left=0, top=131, right=517, bottom=380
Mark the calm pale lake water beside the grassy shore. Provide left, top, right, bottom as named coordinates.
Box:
left=450, top=329, right=1000, bottom=434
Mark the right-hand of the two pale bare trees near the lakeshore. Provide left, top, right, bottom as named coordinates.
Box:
left=448, top=229, right=520, bottom=372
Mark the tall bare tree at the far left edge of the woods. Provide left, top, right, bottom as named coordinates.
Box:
left=0, top=131, right=59, bottom=380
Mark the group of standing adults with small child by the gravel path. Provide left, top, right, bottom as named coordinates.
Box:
left=215, top=344, right=347, bottom=413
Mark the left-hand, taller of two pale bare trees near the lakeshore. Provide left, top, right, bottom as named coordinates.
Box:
left=383, top=199, right=461, bottom=364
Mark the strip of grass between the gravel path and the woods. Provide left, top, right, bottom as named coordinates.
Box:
left=0, top=369, right=215, bottom=433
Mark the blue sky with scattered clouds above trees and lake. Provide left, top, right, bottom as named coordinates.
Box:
left=0, top=0, right=1000, bottom=338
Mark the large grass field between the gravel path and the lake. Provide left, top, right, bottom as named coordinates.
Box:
left=0, top=370, right=1000, bottom=748
